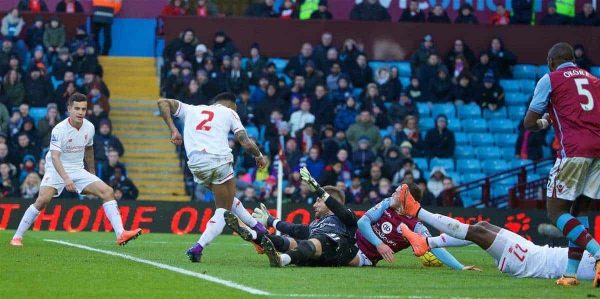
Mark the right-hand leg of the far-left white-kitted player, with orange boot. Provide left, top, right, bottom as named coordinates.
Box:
left=82, top=180, right=142, bottom=246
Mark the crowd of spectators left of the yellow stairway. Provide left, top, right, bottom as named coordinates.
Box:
left=0, top=0, right=138, bottom=199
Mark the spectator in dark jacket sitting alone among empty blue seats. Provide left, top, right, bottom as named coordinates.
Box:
left=424, top=114, right=456, bottom=159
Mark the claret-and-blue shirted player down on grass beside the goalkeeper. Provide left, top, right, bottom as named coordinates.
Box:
left=356, top=183, right=479, bottom=270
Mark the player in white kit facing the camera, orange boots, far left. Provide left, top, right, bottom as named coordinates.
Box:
left=10, top=93, right=142, bottom=246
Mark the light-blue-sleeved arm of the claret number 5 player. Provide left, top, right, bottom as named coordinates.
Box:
left=523, top=74, right=552, bottom=132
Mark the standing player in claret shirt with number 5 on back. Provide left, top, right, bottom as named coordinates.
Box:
left=524, top=43, right=600, bottom=287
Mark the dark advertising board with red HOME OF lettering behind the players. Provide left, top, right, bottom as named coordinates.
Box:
left=0, top=198, right=600, bottom=244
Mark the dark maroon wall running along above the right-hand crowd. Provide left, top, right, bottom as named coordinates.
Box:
left=164, top=16, right=600, bottom=64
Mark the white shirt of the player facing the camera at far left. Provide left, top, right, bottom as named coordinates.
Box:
left=46, top=118, right=94, bottom=173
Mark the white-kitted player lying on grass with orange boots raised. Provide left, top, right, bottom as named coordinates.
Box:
left=396, top=188, right=596, bottom=279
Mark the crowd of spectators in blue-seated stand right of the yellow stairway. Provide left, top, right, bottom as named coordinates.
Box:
left=161, top=25, right=589, bottom=206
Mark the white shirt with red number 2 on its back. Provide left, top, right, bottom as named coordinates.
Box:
left=174, top=102, right=245, bottom=157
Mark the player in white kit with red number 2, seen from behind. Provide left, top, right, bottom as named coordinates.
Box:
left=158, top=92, right=267, bottom=263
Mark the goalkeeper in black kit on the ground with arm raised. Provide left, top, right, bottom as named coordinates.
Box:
left=227, top=168, right=358, bottom=267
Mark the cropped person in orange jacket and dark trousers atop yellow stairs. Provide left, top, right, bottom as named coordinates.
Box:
left=92, top=0, right=121, bottom=55
